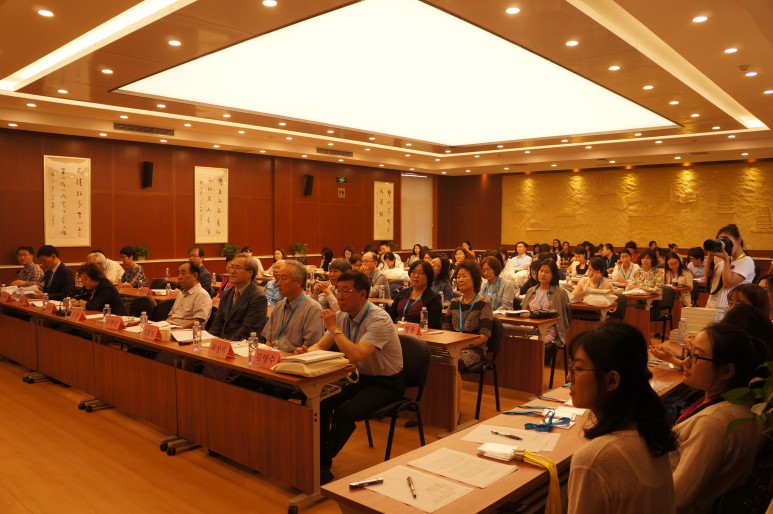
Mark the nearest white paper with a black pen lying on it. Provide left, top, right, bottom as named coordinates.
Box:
left=366, top=466, right=473, bottom=512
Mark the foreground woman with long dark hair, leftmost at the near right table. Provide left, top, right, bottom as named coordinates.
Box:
left=567, top=320, right=676, bottom=514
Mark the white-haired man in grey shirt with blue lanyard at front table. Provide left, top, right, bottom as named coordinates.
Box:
left=261, top=260, right=323, bottom=352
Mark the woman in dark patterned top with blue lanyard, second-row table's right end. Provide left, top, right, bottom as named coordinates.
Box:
left=441, top=259, right=494, bottom=368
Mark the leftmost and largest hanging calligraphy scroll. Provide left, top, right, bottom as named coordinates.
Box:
left=43, top=155, right=91, bottom=247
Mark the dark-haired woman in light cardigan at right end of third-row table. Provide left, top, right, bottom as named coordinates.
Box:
left=521, top=259, right=571, bottom=343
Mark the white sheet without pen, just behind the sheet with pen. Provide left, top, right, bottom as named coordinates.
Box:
left=408, top=441, right=518, bottom=488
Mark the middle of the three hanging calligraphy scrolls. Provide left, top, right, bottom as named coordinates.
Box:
left=193, top=166, right=228, bottom=243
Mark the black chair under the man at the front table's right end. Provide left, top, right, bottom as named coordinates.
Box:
left=365, top=334, right=430, bottom=460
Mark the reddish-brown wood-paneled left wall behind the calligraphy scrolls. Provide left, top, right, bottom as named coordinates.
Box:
left=0, top=130, right=400, bottom=272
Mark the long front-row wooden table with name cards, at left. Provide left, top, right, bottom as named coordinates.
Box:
left=0, top=303, right=353, bottom=506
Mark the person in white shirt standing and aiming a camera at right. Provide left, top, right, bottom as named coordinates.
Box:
left=703, top=223, right=754, bottom=309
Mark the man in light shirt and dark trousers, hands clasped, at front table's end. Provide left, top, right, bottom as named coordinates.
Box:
left=296, top=271, right=405, bottom=483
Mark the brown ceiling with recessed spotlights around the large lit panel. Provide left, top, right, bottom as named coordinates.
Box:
left=0, top=0, right=773, bottom=175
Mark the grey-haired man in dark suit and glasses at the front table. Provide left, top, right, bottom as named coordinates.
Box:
left=208, top=253, right=268, bottom=341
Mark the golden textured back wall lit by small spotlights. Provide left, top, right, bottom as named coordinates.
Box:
left=502, top=162, right=773, bottom=249
